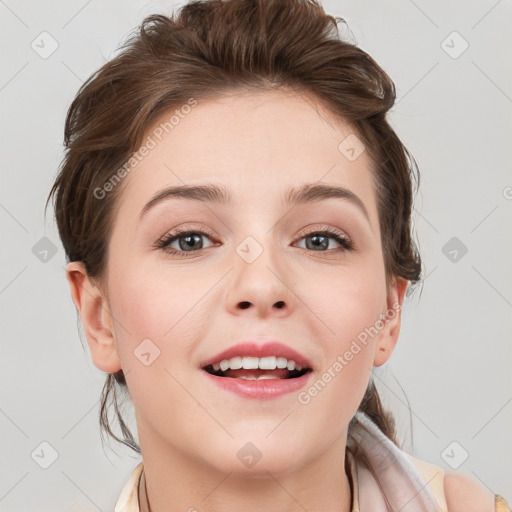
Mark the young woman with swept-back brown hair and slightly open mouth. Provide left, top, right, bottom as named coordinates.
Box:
left=48, top=0, right=510, bottom=512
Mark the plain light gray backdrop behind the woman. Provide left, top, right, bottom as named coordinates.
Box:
left=0, top=0, right=512, bottom=512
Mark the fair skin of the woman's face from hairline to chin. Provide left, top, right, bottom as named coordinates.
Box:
left=75, top=91, right=406, bottom=474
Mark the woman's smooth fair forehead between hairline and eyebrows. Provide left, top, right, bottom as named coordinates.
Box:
left=120, top=90, right=375, bottom=224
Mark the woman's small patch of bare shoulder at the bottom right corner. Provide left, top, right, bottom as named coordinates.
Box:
left=443, top=471, right=494, bottom=512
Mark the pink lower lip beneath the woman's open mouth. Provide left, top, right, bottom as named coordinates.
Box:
left=201, top=370, right=313, bottom=400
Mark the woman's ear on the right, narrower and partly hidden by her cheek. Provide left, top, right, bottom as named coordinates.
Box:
left=373, top=277, right=409, bottom=366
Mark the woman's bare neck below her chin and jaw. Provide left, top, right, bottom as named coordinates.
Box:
left=139, top=428, right=352, bottom=512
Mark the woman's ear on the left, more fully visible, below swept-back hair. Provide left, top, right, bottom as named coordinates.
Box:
left=66, top=261, right=121, bottom=373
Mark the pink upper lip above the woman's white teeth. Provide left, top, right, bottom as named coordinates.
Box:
left=201, top=341, right=312, bottom=369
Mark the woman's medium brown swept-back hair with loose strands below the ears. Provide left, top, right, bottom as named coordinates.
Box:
left=46, top=0, right=421, bottom=453
